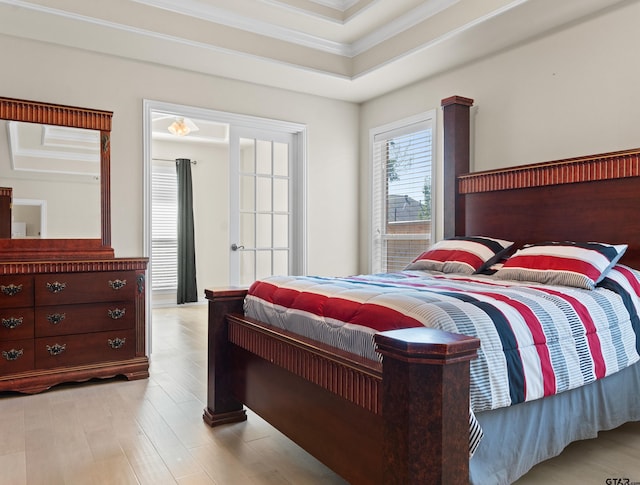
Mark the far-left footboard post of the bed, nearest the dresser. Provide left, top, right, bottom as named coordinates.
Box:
left=202, top=290, right=247, bottom=426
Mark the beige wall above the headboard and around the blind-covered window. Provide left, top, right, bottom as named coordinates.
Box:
left=360, top=1, right=640, bottom=268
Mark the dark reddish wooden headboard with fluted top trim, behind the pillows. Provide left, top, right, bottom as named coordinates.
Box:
left=445, top=97, right=640, bottom=269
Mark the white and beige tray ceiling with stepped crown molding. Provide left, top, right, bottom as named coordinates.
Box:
left=0, top=0, right=625, bottom=102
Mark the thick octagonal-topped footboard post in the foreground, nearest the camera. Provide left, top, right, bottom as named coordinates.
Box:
left=375, top=328, right=480, bottom=485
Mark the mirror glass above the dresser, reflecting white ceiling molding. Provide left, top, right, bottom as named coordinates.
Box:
left=0, top=120, right=101, bottom=239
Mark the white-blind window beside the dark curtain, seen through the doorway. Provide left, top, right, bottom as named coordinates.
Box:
left=151, top=162, right=178, bottom=291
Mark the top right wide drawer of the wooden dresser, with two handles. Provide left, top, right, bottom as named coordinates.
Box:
left=35, top=271, right=137, bottom=306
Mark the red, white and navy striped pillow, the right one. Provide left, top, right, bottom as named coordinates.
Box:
left=495, top=242, right=627, bottom=290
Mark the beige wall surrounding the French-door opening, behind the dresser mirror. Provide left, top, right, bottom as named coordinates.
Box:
left=0, top=36, right=359, bottom=275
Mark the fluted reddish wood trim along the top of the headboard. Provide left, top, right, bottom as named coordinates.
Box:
left=458, top=148, right=640, bottom=194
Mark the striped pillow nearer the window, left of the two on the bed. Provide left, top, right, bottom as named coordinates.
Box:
left=405, top=236, right=513, bottom=274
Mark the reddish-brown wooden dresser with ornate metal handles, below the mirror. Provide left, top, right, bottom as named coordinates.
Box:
left=0, top=258, right=149, bottom=393
